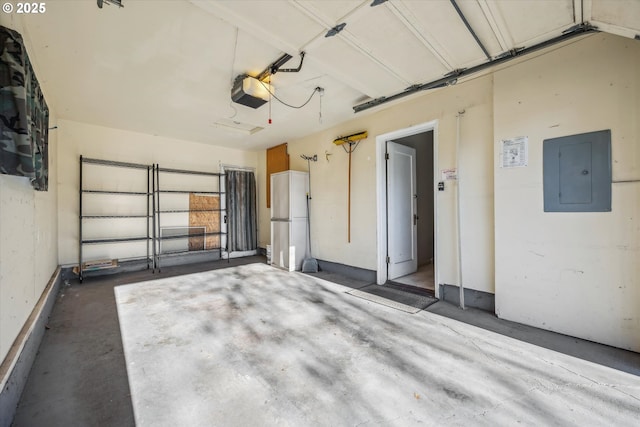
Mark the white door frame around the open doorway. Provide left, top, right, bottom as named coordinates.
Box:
left=376, top=120, right=439, bottom=297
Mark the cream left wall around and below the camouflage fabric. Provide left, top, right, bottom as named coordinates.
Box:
left=0, top=14, right=58, bottom=360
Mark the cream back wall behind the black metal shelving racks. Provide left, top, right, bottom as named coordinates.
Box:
left=58, top=120, right=258, bottom=266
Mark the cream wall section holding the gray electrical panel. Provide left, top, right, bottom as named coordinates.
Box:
left=494, top=34, right=640, bottom=351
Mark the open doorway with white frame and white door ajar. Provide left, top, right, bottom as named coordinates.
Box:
left=376, top=121, right=438, bottom=296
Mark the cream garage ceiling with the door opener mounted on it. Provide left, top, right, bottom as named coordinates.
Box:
left=11, top=0, right=640, bottom=149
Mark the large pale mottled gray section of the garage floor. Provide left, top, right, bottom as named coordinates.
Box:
left=116, top=264, right=640, bottom=426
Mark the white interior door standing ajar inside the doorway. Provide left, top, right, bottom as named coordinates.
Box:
left=387, top=141, right=418, bottom=280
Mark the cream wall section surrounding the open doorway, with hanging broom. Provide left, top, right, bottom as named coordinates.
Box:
left=258, top=75, right=494, bottom=292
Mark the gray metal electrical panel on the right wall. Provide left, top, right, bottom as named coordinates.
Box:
left=543, top=130, right=611, bottom=212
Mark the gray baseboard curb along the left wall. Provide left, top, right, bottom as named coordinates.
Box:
left=0, top=267, right=62, bottom=427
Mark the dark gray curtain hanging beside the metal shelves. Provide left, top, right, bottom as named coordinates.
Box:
left=225, top=170, right=258, bottom=252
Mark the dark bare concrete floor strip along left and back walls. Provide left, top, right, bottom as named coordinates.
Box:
left=12, top=256, right=264, bottom=427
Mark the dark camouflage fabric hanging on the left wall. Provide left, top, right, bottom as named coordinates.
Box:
left=0, top=26, right=49, bottom=191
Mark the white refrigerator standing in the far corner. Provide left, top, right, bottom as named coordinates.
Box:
left=271, top=171, right=309, bottom=271
